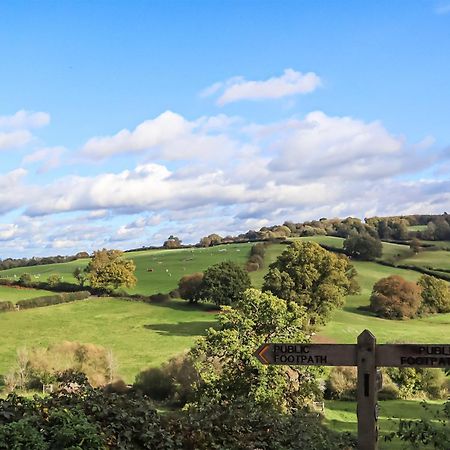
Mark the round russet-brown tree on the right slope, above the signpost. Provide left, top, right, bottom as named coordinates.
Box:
left=370, top=275, right=422, bottom=319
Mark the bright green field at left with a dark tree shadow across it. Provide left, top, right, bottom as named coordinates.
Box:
left=0, top=298, right=215, bottom=382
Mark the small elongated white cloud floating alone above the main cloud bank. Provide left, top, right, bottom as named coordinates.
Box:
left=201, top=69, right=321, bottom=106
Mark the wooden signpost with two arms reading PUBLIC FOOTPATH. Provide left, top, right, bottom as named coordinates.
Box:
left=255, top=330, right=450, bottom=450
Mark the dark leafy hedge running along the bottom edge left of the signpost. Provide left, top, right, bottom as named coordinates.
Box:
left=0, top=373, right=354, bottom=450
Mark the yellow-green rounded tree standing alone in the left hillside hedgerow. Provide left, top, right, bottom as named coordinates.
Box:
left=86, top=249, right=137, bottom=290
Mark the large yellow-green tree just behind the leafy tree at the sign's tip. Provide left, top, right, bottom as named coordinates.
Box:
left=263, top=241, right=351, bottom=325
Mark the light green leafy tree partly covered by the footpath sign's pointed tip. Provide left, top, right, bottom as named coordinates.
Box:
left=190, top=289, right=319, bottom=411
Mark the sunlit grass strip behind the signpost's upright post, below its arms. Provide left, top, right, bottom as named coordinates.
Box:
left=324, top=400, right=442, bottom=450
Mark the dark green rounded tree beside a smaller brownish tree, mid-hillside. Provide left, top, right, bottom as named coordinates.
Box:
left=195, top=261, right=251, bottom=306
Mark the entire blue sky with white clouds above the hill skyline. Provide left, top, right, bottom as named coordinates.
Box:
left=0, top=0, right=450, bottom=258
